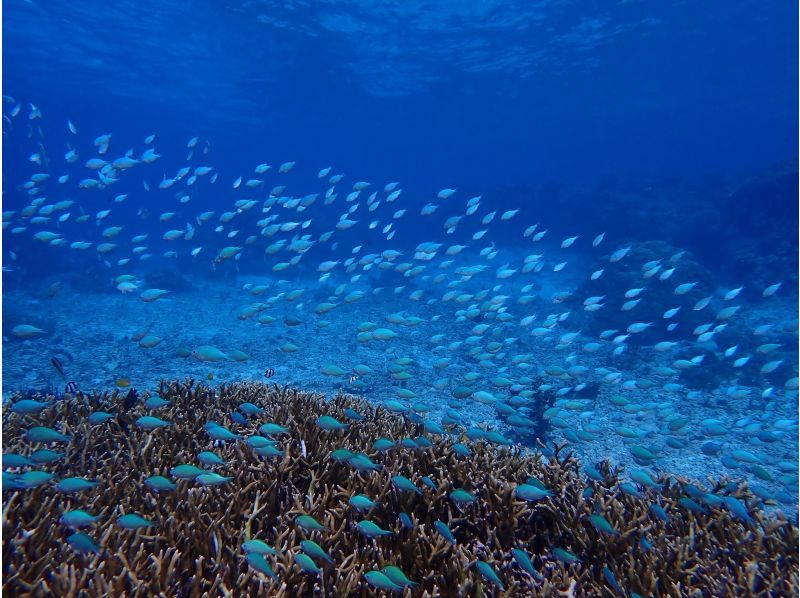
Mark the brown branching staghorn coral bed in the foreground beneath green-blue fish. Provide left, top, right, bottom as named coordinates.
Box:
left=3, top=381, right=798, bottom=596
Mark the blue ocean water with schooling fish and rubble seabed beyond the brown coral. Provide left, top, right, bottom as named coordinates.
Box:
left=2, top=0, right=798, bottom=592
